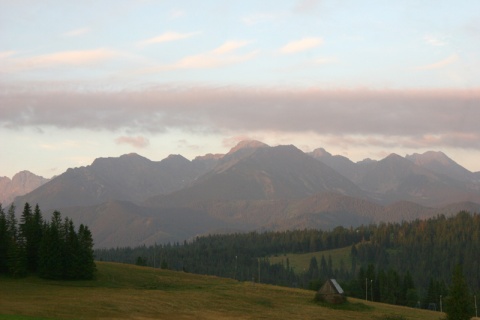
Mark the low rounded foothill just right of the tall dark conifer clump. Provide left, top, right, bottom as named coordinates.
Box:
left=57, top=201, right=226, bottom=248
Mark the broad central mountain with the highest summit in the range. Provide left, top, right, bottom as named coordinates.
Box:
left=149, top=142, right=365, bottom=205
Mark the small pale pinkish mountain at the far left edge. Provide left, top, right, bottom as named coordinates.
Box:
left=0, top=171, right=50, bottom=206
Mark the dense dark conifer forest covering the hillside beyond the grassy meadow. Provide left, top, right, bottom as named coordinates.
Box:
left=95, top=212, right=480, bottom=309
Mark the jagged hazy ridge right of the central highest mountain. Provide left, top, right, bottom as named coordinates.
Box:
left=310, top=149, right=480, bottom=207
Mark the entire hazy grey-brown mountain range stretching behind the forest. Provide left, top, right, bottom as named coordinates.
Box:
left=0, top=141, right=480, bottom=247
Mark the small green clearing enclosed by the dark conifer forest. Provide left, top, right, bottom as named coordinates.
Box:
left=269, top=246, right=352, bottom=274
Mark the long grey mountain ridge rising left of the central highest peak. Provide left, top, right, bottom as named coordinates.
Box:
left=16, top=154, right=218, bottom=209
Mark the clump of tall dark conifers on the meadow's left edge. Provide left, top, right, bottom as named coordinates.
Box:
left=0, top=203, right=96, bottom=280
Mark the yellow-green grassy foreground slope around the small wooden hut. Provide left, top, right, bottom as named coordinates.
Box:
left=0, top=262, right=440, bottom=320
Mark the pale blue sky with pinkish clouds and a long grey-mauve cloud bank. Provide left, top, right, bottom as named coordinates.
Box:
left=0, top=0, right=480, bottom=178
